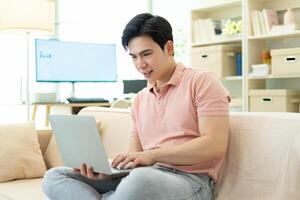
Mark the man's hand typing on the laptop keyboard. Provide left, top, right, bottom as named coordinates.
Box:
left=111, top=150, right=156, bottom=169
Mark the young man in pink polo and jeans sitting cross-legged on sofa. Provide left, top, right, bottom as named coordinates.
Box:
left=43, top=13, right=230, bottom=200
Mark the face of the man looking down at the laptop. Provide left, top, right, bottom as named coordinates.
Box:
left=128, top=36, right=173, bottom=83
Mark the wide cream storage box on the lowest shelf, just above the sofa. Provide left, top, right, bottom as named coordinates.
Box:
left=249, top=89, right=300, bottom=112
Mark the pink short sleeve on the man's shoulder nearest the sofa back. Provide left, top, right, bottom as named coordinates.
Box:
left=195, top=72, right=230, bottom=117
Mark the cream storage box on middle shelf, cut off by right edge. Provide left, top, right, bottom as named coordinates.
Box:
left=271, top=48, right=300, bottom=76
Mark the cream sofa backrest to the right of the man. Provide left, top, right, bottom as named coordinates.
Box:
left=214, top=113, right=300, bottom=200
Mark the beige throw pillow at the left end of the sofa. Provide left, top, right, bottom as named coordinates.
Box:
left=0, top=123, right=46, bottom=182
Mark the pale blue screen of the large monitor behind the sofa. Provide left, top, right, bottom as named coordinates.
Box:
left=35, top=39, right=117, bottom=82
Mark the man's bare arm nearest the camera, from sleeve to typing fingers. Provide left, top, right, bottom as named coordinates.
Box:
left=113, top=116, right=229, bottom=167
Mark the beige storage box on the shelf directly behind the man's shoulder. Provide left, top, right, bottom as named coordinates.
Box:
left=191, top=45, right=241, bottom=78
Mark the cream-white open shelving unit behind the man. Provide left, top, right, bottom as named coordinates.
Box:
left=191, top=0, right=300, bottom=111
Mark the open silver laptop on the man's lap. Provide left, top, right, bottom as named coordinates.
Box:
left=49, top=115, right=130, bottom=175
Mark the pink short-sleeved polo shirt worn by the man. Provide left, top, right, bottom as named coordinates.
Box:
left=130, top=63, right=230, bottom=181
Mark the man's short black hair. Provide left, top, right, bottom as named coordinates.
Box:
left=122, top=13, right=173, bottom=50
